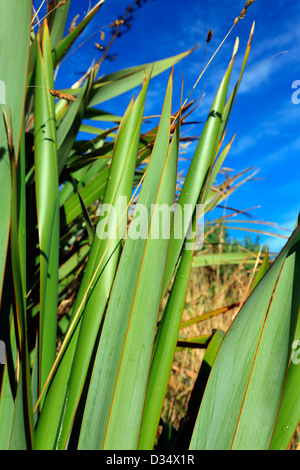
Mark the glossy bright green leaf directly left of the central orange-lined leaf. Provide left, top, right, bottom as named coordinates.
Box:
left=37, top=73, right=149, bottom=448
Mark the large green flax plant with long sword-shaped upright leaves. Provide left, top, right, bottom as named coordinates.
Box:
left=0, top=0, right=300, bottom=450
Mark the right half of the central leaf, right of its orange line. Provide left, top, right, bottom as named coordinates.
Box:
left=104, top=94, right=179, bottom=449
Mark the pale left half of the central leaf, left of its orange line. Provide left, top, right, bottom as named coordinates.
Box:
left=79, top=70, right=176, bottom=449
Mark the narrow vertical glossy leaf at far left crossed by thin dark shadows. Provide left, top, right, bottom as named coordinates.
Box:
left=34, top=23, right=59, bottom=404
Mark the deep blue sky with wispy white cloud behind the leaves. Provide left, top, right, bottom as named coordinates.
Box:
left=52, top=0, right=300, bottom=251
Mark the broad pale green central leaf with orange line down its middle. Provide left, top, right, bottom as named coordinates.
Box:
left=79, top=70, right=177, bottom=449
